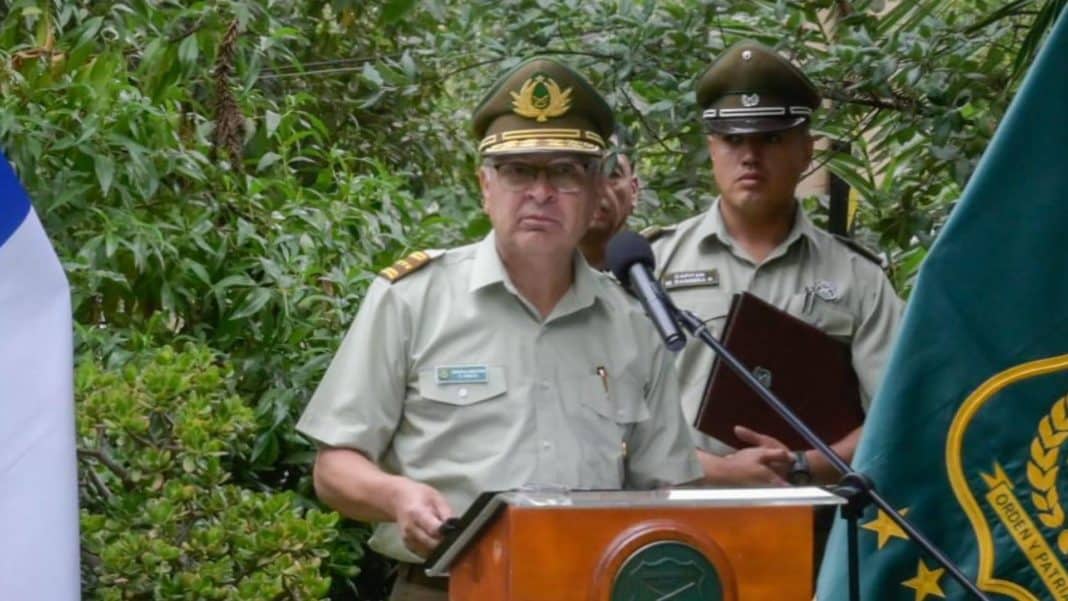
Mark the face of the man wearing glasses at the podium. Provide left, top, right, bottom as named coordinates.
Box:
left=478, top=153, right=599, bottom=254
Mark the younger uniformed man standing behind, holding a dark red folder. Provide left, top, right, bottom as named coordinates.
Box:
left=647, top=42, right=902, bottom=486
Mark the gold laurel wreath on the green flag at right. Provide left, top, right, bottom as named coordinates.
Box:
left=1027, top=396, right=1068, bottom=555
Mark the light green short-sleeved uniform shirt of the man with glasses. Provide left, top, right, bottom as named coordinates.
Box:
left=298, top=234, right=701, bottom=562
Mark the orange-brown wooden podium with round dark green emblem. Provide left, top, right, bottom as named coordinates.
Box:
left=427, top=488, right=844, bottom=601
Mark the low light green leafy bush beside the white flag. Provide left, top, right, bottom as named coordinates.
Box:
left=76, top=345, right=337, bottom=600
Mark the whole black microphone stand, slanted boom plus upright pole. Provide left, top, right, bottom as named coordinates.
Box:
left=665, top=307, right=990, bottom=601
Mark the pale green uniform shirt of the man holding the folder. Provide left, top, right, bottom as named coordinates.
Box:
left=653, top=201, right=904, bottom=455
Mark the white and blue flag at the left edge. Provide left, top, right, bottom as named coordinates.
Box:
left=0, top=154, right=80, bottom=601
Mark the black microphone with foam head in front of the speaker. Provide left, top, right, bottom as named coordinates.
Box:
left=608, top=230, right=686, bottom=352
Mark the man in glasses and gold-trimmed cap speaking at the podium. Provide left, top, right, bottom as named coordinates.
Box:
left=298, top=59, right=701, bottom=600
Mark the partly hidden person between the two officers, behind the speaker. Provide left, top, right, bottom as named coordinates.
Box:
left=579, top=136, right=640, bottom=271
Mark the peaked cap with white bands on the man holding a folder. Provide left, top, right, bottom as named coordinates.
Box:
left=697, top=39, right=820, bottom=133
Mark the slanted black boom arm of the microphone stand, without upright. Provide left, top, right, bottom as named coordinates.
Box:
left=670, top=305, right=990, bottom=601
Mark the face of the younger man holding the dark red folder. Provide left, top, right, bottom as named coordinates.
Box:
left=708, top=127, right=813, bottom=218
